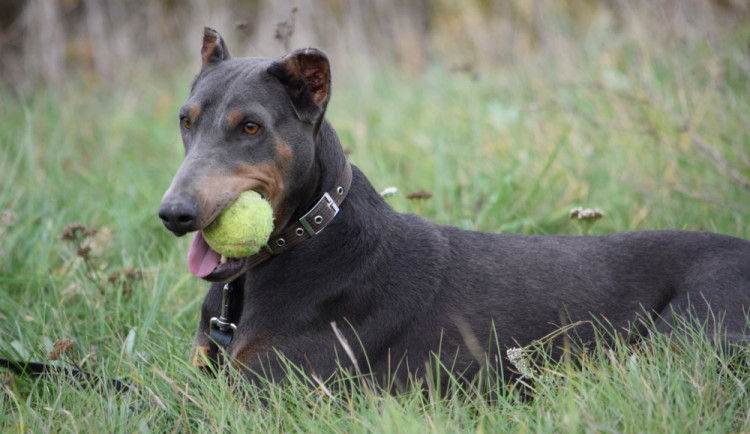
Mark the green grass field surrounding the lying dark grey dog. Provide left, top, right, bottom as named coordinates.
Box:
left=0, top=24, right=750, bottom=432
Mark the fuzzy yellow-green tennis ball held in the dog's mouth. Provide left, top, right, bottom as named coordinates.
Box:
left=203, top=190, right=273, bottom=258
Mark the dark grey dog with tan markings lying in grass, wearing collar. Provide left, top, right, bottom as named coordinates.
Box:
left=159, top=28, right=750, bottom=390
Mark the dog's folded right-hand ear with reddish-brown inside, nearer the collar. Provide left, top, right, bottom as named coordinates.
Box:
left=268, top=48, right=331, bottom=131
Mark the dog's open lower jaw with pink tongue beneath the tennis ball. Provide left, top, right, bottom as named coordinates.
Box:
left=188, top=231, right=254, bottom=282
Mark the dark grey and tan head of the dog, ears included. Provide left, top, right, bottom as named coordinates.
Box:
left=159, top=28, right=331, bottom=281
